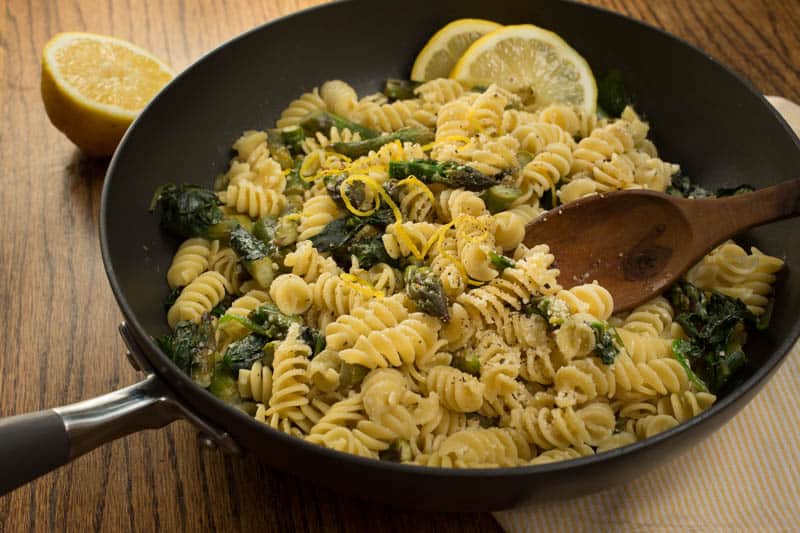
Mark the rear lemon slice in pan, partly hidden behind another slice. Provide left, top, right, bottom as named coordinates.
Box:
left=411, top=19, right=502, bottom=81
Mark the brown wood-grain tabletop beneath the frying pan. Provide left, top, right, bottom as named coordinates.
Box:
left=0, top=0, right=800, bottom=533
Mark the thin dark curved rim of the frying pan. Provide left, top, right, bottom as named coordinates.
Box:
left=98, top=0, right=800, bottom=480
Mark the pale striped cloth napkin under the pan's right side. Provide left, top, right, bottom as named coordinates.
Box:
left=494, top=97, right=800, bottom=533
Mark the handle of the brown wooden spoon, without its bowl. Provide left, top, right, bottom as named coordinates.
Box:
left=679, top=178, right=800, bottom=249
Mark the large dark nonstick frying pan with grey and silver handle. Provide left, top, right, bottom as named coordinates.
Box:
left=0, top=0, right=800, bottom=511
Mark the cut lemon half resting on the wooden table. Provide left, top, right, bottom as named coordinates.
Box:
left=41, top=33, right=173, bottom=156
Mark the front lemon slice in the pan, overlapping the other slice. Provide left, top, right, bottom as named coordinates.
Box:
left=450, top=24, right=597, bottom=114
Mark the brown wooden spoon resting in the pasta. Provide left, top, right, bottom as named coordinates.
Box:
left=524, top=178, right=800, bottom=311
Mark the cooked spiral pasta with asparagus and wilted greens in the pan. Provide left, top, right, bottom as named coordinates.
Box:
left=153, top=67, right=783, bottom=468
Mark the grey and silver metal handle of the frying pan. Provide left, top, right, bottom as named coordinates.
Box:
left=0, top=374, right=177, bottom=496
